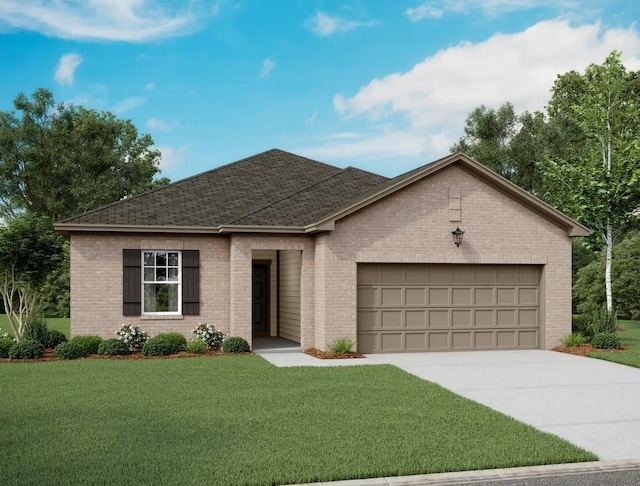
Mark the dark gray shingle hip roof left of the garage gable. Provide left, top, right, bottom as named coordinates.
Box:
left=62, top=149, right=389, bottom=227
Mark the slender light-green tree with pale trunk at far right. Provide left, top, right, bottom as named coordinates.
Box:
left=540, top=52, right=640, bottom=310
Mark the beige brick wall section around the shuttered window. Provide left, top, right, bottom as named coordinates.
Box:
left=71, top=233, right=230, bottom=338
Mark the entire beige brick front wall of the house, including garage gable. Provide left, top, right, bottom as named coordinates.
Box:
left=71, top=166, right=571, bottom=349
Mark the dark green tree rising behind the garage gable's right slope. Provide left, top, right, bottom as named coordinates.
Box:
left=451, top=102, right=549, bottom=194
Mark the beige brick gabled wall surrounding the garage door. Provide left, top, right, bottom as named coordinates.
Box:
left=315, top=166, right=571, bottom=348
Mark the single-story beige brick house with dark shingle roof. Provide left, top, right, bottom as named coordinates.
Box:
left=56, top=150, right=589, bottom=353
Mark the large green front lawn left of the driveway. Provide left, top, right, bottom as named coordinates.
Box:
left=0, top=356, right=596, bottom=485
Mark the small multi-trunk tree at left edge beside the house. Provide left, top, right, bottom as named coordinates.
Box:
left=0, top=213, right=64, bottom=341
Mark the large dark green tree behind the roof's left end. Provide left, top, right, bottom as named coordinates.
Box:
left=0, top=89, right=168, bottom=221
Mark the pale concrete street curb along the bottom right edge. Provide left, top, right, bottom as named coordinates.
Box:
left=298, top=459, right=640, bottom=486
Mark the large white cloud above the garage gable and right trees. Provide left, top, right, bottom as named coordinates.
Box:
left=301, top=20, right=640, bottom=167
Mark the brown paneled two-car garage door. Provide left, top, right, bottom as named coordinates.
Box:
left=358, top=263, right=540, bottom=353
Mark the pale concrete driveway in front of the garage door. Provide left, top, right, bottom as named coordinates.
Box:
left=358, top=350, right=640, bottom=460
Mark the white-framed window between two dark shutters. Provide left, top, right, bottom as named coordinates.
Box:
left=142, top=250, right=182, bottom=314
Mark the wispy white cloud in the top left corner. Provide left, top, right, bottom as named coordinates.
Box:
left=0, top=0, right=217, bottom=42
